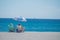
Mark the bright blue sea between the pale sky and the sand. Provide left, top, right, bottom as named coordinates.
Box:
left=0, top=18, right=60, bottom=32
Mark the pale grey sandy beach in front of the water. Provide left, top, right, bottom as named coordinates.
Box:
left=0, top=32, right=60, bottom=40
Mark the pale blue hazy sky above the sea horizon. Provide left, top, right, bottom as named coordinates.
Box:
left=0, top=0, right=60, bottom=19
